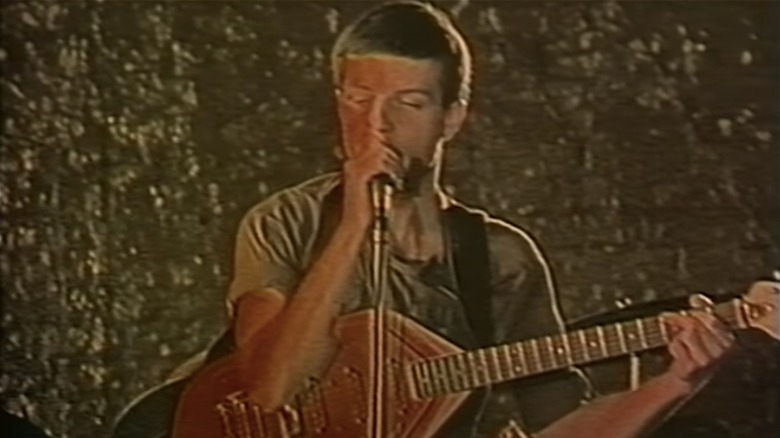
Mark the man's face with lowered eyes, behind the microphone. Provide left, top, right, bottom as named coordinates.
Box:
left=338, top=55, right=462, bottom=175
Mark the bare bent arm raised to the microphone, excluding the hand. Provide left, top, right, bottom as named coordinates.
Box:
left=235, top=207, right=370, bottom=410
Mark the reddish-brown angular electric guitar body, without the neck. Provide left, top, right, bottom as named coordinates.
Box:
left=173, top=310, right=469, bottom=438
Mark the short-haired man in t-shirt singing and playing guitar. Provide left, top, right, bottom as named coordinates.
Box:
left=222, top=2, right=733, bottom=438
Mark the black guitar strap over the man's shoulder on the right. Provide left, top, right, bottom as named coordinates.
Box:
left=445, top=205, right=495, bottom=347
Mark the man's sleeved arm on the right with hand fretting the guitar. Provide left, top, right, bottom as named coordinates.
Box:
left=492, top=222, right=734, bottom=438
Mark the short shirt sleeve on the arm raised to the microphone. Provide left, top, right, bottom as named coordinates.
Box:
left=227, top=202, right=301, bottom=318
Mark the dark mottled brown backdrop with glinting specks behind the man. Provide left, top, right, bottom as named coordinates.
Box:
left=0, top=0, right=780, bottom=438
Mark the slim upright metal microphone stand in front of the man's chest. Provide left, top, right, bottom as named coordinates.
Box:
left=367, top=178, right=394, bottom=438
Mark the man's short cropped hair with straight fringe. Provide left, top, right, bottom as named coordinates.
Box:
left=331, top=1, right=472, bottom=106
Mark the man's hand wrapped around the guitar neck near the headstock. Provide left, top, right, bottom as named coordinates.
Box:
left=663, top=294, right=734, bottom=390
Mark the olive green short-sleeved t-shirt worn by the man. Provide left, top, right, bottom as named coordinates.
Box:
left=227, top=173, right=580, bottom=436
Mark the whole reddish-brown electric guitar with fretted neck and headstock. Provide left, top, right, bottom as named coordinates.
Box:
left=173, top=281, right=780, bottom=438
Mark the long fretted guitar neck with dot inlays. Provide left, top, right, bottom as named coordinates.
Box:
left=409, top=299, right=744, bottom=397
